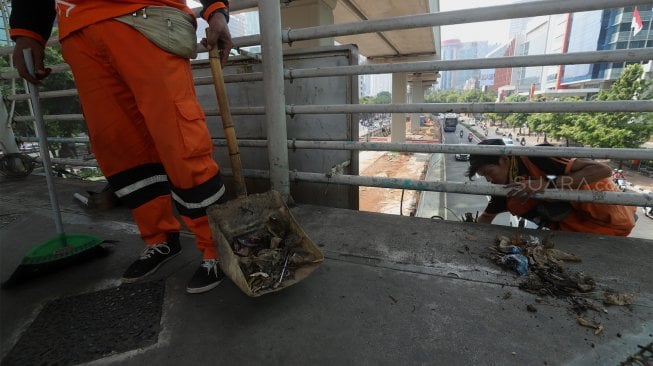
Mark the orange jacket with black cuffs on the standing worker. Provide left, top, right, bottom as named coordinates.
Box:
left=10, top=0, right=229, bottom=44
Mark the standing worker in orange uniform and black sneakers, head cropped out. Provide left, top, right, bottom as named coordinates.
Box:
left=10, top=0, right=232, bottom=293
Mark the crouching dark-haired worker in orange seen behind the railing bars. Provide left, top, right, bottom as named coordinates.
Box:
left=466, top=139, right=635, bottom=236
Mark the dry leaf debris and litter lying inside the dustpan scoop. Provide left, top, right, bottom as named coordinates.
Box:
left=231, top=215, right=317, bottom=293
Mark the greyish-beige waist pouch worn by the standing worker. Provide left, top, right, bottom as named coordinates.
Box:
left=115, top=6, right=197, bottom=58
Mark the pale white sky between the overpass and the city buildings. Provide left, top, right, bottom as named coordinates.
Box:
left=440, top=0, right=514, bottom=43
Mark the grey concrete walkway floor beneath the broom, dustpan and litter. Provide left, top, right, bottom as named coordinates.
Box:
left=0, top=176, right=653, bottom=365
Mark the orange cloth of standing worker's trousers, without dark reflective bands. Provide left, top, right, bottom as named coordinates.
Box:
left=62, top=20, right=223, bottom=259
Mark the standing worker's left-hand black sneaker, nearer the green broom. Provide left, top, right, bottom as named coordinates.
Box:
left=122, top=233, right=181, bottom=283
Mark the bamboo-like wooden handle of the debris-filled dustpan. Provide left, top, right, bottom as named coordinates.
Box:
left=209, top=41, right=247, bottom=197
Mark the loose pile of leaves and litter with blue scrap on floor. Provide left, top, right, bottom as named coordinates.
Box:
left=489, top=235, right=636, bottom=334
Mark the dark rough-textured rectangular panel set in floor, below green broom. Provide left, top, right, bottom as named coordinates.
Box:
left=2, top=281, right=165, bottom=366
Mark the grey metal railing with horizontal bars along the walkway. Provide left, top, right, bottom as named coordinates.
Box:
left=0, top=0, right=653, bottom=206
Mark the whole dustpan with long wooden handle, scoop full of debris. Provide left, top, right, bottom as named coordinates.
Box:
left=207, top=42, right=324, bottom=297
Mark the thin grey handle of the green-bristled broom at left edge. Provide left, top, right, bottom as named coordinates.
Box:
left=23, top=48, right=65, bottom=237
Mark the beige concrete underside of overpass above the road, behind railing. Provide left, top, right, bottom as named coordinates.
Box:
left=333, top=0, right=440, bottom=62
